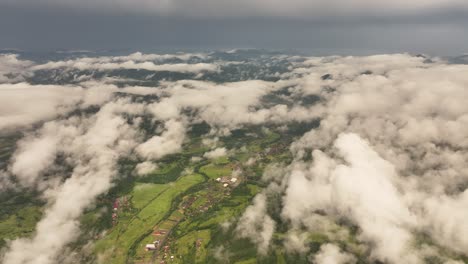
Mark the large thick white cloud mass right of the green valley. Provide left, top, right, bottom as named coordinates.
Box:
left=238, top=54, right=468, bottom=263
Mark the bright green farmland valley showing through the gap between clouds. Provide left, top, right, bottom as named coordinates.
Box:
left=86, top=129, right=292, bottom=263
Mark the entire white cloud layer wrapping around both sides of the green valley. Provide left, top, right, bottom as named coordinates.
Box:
left=4, top=50, right=468, bottom=263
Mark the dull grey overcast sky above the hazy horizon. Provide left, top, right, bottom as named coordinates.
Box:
left=0, top=0, right=468, bottom=55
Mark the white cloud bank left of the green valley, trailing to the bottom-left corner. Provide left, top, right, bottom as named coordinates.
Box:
left=1, top=51, right=310, bottom=263
